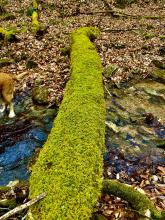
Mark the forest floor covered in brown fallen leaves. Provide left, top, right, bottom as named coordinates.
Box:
left=0, top=0, right=165, bottom=220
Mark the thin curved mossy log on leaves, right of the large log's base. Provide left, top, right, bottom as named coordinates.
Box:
left=102, top=180, right=165, bottom=220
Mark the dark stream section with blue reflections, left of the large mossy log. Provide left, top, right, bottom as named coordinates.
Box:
left=0, top=96, right=57, bottom=186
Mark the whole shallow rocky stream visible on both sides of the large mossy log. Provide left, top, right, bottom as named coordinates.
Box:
left=0, top=75, right=165, bottom=185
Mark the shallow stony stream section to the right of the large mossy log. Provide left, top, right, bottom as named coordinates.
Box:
left=104, top=78, right=165, bottom=184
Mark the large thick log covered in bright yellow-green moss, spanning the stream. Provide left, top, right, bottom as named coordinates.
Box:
left=30, top=27, right=105, bottom=220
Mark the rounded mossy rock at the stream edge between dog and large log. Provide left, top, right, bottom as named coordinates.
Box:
left=32, top=86, right=49, bottom=105
